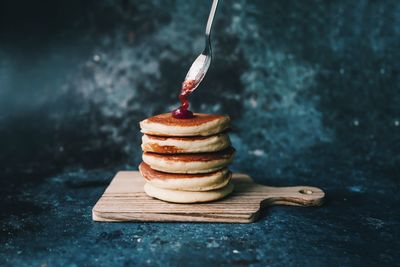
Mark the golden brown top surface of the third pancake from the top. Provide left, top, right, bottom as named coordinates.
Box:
left=144, top=147, right=235, bottom=162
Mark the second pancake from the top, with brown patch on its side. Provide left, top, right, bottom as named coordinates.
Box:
left=142, top=133, right=231, bottom=154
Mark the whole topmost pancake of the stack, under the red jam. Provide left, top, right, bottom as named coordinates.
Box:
left=140, top=113, right=230, bottom=136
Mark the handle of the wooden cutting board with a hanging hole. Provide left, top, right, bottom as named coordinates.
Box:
left=263, top=186, right=325, bottom=206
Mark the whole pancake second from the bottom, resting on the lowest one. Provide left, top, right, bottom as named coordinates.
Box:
left=139, top=162, right=232, bottom=191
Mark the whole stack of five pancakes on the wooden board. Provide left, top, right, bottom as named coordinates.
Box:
left=139, top=113, right=235, bottom=203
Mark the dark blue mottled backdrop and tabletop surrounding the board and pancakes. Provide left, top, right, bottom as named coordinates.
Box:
left=0, top=0, right=400, bottom=266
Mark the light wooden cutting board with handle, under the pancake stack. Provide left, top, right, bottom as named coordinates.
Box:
left=92, top=171, right=325, bottom=223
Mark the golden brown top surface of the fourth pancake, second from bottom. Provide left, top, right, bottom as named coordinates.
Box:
left=139, top=162, right=230, bottom=180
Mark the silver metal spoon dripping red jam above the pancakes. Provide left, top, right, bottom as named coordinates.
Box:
left=184, top=0, right=218, bottom=93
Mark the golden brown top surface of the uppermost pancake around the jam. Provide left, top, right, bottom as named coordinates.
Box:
left=147, top=113, right=229, bottom=127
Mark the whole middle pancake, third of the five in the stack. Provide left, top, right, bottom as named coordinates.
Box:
left=142, top=147, right=235, bottom=173
